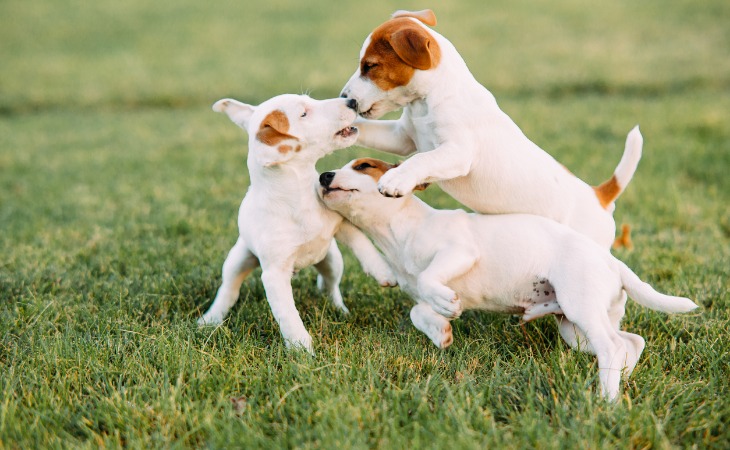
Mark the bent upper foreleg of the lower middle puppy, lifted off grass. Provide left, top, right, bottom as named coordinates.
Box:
left=418, top=247, right=477, bottom=319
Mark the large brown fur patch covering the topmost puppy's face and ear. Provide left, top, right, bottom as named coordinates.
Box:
left=360, top=17, right=441, bottom=91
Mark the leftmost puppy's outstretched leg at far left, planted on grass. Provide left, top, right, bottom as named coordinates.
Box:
left=198, top=238, right=259, bottom=326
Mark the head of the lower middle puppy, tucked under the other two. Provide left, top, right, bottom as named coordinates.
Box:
left=317, top=158, right=428, bottom=221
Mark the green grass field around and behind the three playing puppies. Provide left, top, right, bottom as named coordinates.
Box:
left=0, top=0, right=730, bottom=449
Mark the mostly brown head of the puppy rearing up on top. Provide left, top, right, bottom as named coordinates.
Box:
left=341, top=9, right=441, bottom=119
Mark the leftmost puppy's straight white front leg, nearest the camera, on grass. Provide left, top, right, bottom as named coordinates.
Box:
left=261, top=266, right=314, bottom=354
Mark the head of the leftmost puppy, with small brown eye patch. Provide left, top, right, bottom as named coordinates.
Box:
left=213, top=94, right=357, bottom=167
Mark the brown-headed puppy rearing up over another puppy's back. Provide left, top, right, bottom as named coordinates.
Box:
left=341, top=10, right=643, bottom=248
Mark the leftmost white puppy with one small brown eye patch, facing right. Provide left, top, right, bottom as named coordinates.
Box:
left=198, top=94, right=395, bottom=353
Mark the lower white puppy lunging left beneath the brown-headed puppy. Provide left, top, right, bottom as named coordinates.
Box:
left=318, top=158, right=697, bottom=400
